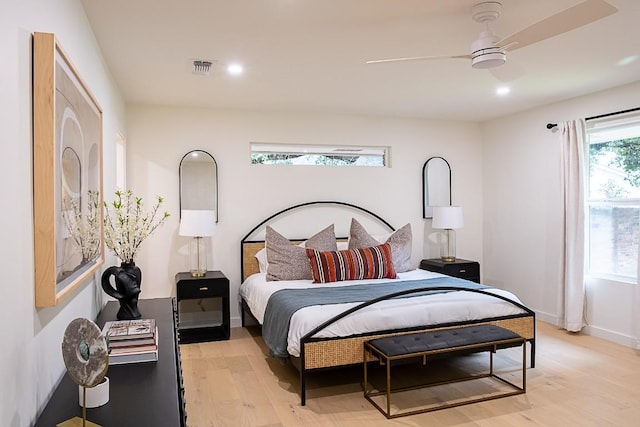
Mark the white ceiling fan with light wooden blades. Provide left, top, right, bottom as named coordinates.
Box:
left=366, top=0, right=618, bottom=69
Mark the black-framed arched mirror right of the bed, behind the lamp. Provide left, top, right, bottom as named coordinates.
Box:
left=422, top=157, right=451, bottom=218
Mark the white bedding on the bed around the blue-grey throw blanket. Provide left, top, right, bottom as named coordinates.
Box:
left=240, top=269, right=524, bottom=357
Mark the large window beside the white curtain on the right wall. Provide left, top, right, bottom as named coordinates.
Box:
left=587, top=114, right=640, bottom=281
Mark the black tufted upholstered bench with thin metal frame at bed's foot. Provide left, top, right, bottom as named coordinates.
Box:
left=364, top=324, right=527, bottom=418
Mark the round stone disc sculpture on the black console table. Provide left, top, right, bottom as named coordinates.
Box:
left=62, top=318, right=109, bottom=387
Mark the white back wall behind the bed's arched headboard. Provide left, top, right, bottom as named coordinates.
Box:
left=127, top=106, right=482, bottom=325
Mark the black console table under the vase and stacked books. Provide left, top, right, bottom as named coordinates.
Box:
left=35, top=298, right=186, bottom=427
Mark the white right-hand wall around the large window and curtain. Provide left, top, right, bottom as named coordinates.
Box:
left=482, top=82, right=640, bottom=346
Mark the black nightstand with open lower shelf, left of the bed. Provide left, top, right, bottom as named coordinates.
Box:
left=176, top=271, right=231, bottom=344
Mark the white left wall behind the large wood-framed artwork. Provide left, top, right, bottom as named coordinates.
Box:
left=0, top=0, right=124, bottom=427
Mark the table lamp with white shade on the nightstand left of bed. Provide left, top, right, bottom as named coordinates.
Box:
left=178, top=209, right=216, bottom=277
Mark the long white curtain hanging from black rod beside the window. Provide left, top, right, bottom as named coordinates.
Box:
left=561, top=120, right=586, bottom=332
